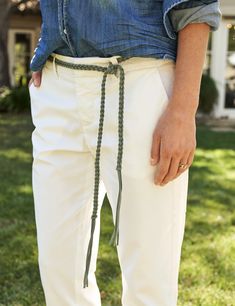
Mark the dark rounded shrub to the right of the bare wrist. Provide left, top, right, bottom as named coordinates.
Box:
left=198, top=74, right=219, bottom=114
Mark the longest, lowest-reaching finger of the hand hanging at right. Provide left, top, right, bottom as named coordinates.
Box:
left=154, top=142, right=171, bottom=185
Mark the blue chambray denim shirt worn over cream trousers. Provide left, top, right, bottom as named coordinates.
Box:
left=30, top=0, right=222, bottom=71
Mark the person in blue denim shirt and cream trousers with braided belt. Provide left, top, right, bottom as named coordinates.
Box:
left=29, top=0, right=221, bottom=306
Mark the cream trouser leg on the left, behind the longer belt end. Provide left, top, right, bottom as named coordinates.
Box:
left=30, top=62, right=105, bottom=306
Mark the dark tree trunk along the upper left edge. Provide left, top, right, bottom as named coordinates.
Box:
left=0, top=0, right=38, bottom=87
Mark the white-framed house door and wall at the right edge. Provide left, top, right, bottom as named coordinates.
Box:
left=210, top=0, right=235, bottom=118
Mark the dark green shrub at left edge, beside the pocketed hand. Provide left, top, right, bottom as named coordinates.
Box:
left=0, top=86, right=30, bottom=113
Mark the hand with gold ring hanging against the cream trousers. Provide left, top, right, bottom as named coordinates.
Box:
left=150, top=107, right=196, bottom=186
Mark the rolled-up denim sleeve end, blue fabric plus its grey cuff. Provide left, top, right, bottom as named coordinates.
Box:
left=163, top=0, right=222, bottom=39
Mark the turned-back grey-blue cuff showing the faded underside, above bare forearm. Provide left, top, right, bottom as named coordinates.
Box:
left=169, top=2, right=222, bottom=32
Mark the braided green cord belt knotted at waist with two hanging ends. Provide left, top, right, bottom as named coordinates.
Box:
left=48, top=56, right=129, bottom=288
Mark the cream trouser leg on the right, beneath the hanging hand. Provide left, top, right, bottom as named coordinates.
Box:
left=98, top=60, right=188, bottom=306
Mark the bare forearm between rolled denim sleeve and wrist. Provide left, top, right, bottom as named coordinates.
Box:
left=168, top=23, right=210, bottom=116
